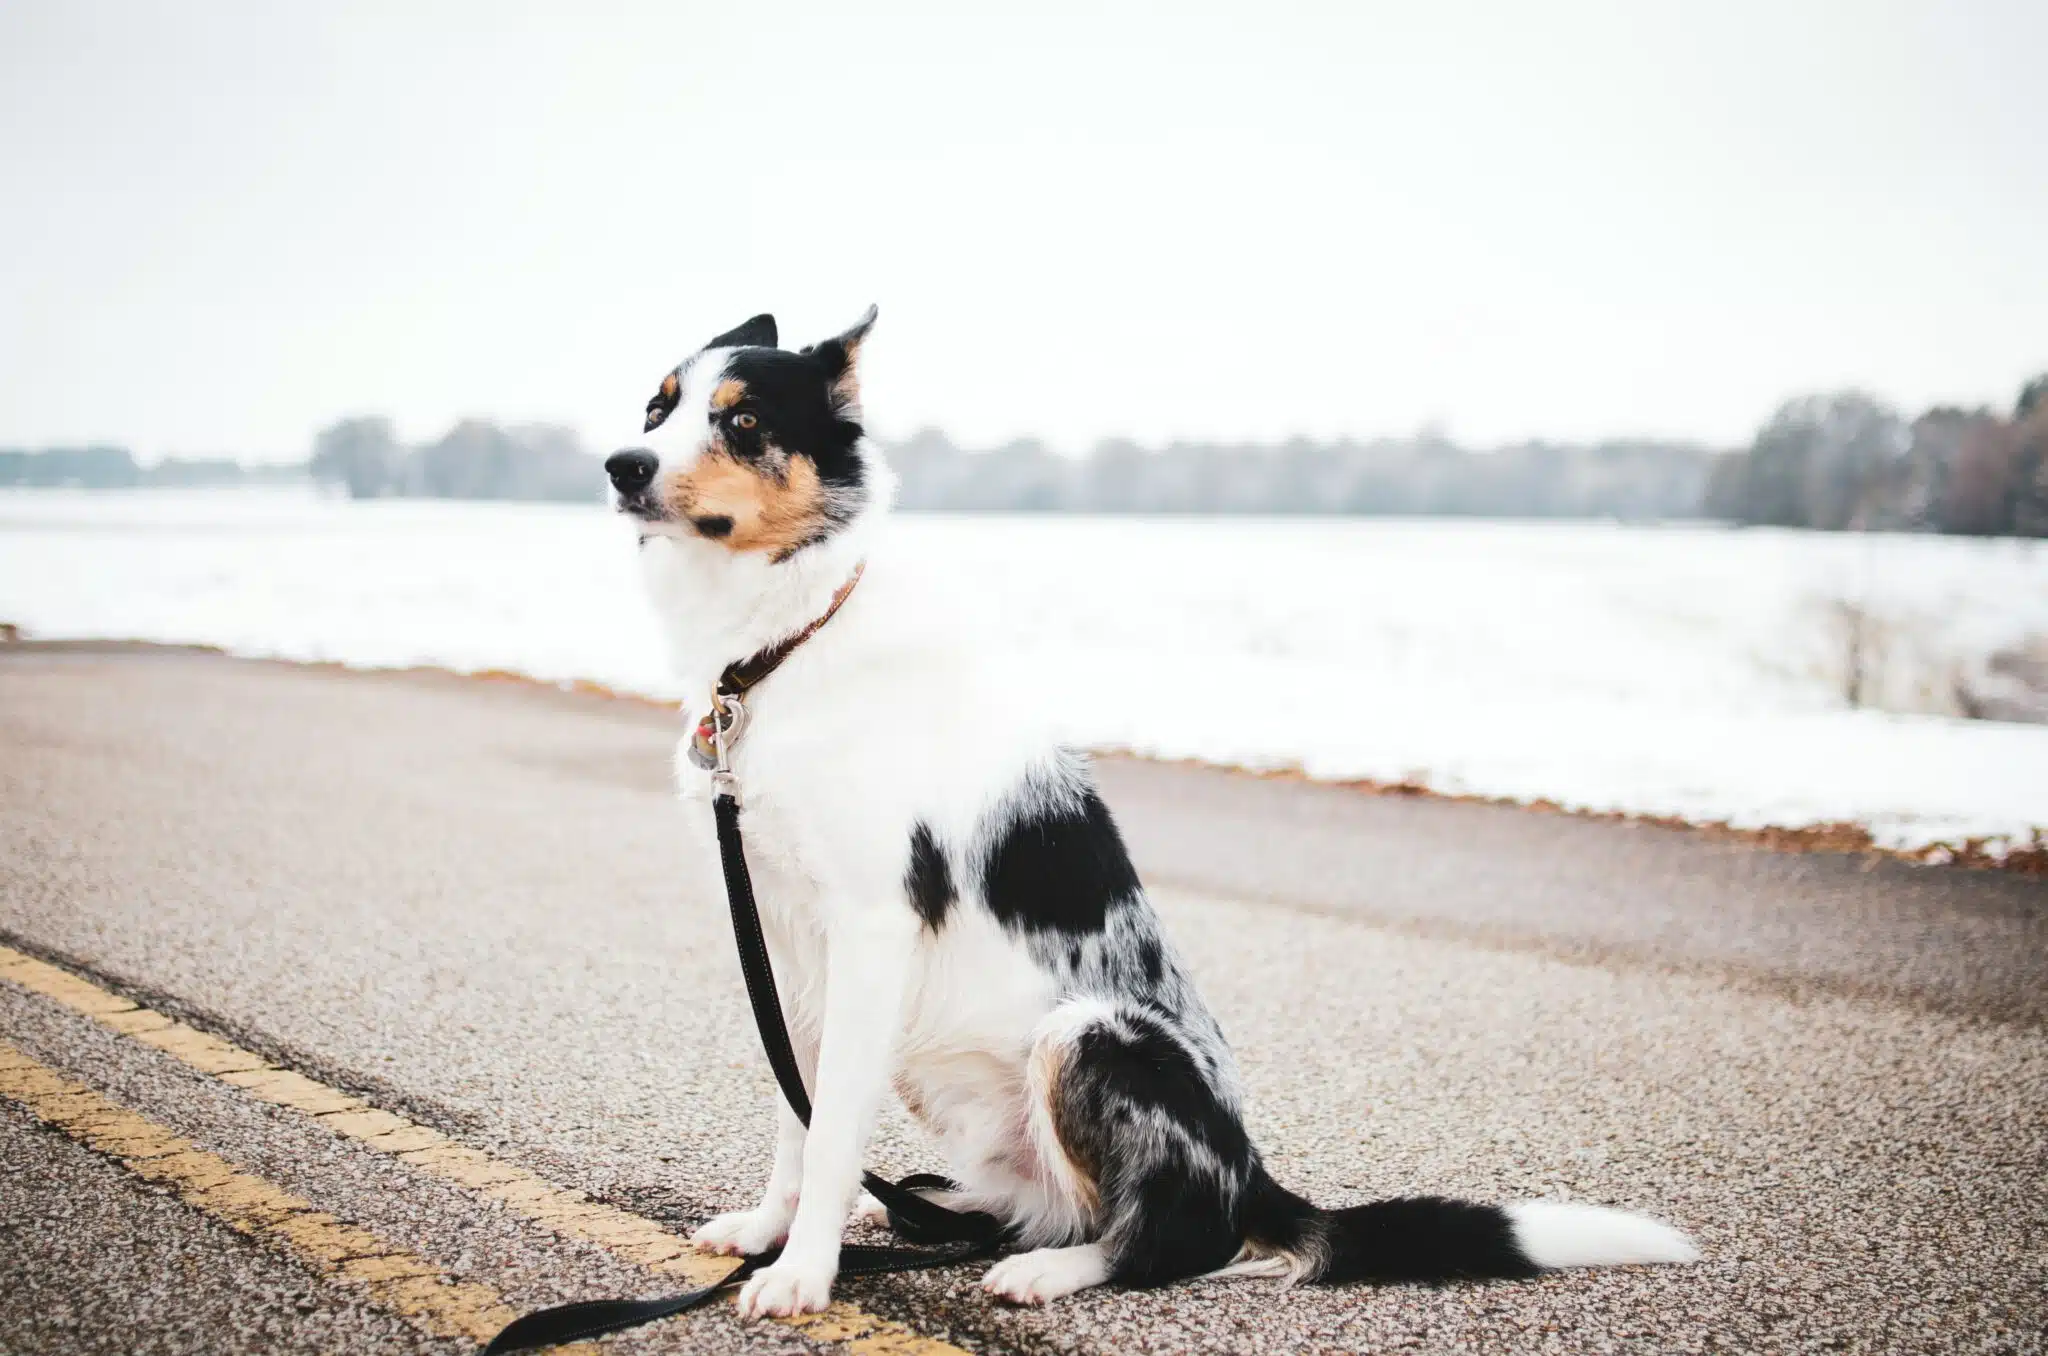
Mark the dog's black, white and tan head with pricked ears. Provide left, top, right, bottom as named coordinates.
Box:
left=604, top=305, right=874, bottom=561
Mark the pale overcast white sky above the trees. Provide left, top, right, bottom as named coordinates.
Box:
left=0, top=0, right=2048, bottom=457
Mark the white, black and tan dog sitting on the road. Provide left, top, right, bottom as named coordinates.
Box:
left=606, top=307, right=1698, bottom=1317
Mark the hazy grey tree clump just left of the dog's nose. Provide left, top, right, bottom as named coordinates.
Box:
left=307, top=418, right=604, bottom=500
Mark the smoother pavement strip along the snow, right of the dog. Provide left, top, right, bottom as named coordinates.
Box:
left=1100, top=758, right=2048, bottom=1026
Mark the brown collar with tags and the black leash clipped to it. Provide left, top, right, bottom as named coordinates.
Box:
left=483, top=569, right=1006, bottom=1356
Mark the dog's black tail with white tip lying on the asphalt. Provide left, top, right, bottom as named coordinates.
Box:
left=1225, top=1168, right=1700, bottom=1284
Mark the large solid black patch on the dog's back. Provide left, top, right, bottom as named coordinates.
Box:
left=981, top=789, right=1139, bottom=934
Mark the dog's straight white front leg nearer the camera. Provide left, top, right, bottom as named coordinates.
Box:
left=739, top=905, right=918, bottom=1319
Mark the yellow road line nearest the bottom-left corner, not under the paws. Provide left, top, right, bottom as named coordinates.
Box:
left=0, top=1041, right=544, bottom=1350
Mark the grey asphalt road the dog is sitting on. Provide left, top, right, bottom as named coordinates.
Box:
left=0, top=645, right=2048, bottom=1354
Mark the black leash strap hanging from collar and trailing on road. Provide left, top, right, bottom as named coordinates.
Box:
left=483, top=791, right=1006, bottom=1356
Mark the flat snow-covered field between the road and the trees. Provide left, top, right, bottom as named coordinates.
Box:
left=0, top=492, right=2048, bottom=854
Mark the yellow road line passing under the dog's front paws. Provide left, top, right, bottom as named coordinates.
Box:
left=0, top=946, right=969, bottom=1356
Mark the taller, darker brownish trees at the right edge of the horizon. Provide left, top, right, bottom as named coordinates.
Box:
left=1706, top=375, right=2048, bottom=537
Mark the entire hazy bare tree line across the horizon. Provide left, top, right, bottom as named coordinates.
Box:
left=0, top=375, right=2048, bottom=537
